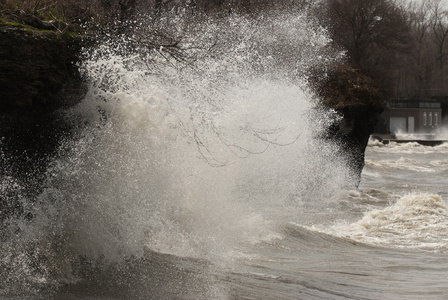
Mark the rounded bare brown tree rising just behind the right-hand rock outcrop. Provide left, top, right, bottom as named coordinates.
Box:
left=324, top=0, right=408, bottom=94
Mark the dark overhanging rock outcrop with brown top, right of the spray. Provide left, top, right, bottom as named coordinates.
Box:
left=310, top=64, right=383, bottom=187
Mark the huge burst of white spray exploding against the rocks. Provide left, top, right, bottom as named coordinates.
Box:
left=0, top=9, right=348, bottom=298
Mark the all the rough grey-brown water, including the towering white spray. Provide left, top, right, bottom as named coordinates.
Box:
left=0, top=9, right=448, bottom=299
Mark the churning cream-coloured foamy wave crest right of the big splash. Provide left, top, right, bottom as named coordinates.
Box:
left=329, top=194, right=448, bottom=252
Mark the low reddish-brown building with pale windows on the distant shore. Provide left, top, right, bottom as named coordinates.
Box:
left=376, top=99, right=442, bottom=135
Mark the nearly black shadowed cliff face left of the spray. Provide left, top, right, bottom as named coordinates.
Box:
left=0, top=24, right=83, bottom=221
